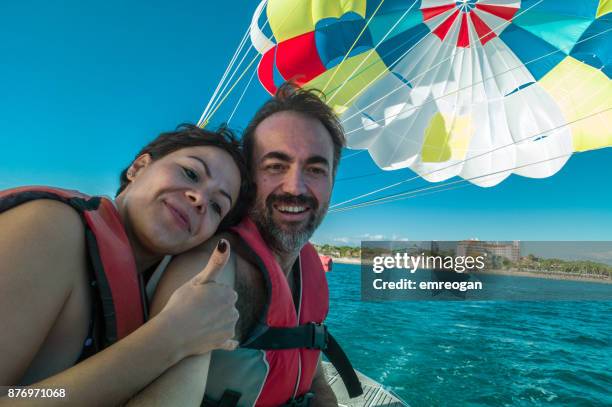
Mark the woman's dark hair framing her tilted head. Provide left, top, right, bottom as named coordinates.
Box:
left=117, top=123, right=252, bottom=229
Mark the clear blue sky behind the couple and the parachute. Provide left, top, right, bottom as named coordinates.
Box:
left=0, top=0, right=612, bottom=244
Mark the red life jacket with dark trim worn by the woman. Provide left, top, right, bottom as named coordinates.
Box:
left=0, top=186, right=146, bottom=347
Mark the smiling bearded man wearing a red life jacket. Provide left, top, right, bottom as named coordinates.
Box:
left=136, top=84, right=361, bottom=406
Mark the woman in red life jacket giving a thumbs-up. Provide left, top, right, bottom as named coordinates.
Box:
left=0, top=126, right=249, bottom=405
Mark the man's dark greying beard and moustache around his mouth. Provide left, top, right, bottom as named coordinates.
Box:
left=250, top=194, right=329, bottom=253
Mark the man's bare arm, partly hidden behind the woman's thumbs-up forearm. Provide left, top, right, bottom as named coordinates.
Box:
left=128, top=238, right=238, bottom=407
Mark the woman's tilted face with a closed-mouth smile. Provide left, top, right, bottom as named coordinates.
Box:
left=117, top=146, right=240, bottom=254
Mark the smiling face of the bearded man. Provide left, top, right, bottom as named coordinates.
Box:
left=251, top=111, right=334, bottom=253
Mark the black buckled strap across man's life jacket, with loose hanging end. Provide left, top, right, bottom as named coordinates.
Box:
left=241, top=322, right=363, bottom=398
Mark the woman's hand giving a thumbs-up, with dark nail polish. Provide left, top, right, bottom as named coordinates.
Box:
left=155, top=239, right=238, bottom=357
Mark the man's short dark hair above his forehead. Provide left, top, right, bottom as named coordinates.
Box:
left=242, top=82, right=346, bottom=177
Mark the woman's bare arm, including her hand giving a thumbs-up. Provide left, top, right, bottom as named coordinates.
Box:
left=0, top=200, right=237, bottom=406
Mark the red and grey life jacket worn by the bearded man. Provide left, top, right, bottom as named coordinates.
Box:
left=204, top=218, right=361, bottom=406
